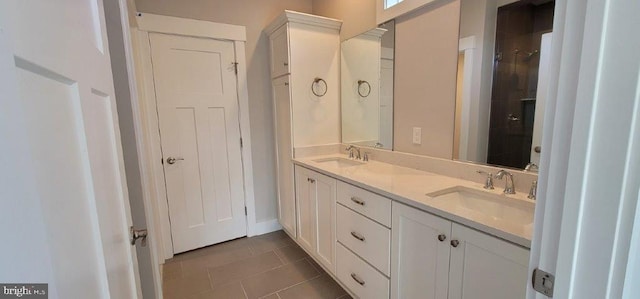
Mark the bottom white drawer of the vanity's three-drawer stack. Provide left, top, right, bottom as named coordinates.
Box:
left=336, top=243, right=389, bottom=299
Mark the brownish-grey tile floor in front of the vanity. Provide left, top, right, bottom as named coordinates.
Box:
left=163, top=231, right=351, bottom=299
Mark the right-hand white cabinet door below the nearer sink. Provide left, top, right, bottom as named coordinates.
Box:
left=449, top=224, right=529, bottom=299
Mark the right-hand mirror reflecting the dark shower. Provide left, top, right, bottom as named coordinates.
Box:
left=453, top=0, right=555, bottom=169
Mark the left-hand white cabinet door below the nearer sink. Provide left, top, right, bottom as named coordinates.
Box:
left=391, top=202, right=450, bottom=299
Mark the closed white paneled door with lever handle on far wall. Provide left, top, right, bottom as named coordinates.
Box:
left=149, top=33, right=247, bottom=253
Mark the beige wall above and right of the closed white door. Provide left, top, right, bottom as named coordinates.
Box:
left=136, top=0, right=312, bottom=222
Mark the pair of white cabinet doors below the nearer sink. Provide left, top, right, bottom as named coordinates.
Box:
left=391, top=202, right=529, bottom=299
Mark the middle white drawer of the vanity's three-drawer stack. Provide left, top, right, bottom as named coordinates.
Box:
left=336, top=204, right=391, bottom=276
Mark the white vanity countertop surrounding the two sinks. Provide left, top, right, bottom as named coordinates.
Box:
left=294, top=154, right=534, bottom=248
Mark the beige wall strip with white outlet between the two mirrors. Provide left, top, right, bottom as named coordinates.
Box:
left=393, top=0, right=460, bottom=159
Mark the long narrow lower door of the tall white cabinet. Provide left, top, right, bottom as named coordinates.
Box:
left=273, top=76, right=296, bottom=238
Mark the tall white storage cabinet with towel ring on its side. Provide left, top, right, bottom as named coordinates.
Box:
left=265, top=11, right=342, bottom=238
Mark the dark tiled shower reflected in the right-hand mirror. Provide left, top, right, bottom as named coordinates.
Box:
left=487, top=1, right=554, bottom=168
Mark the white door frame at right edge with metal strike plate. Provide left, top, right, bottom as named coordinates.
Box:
left=527, top=0, right=640, bottom=299
